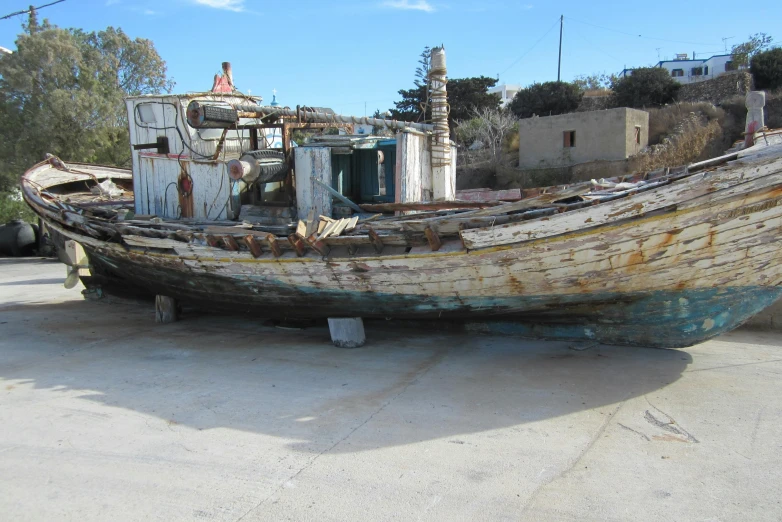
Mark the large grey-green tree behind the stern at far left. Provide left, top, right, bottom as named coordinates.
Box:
left=0, top=12, right=173, bottom=190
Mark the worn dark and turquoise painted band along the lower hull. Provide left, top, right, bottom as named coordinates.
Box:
left=90, top=246, right=782, bottom=348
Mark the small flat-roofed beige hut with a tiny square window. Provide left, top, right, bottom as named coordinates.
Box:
left=519, top=107, right=649, bottom=169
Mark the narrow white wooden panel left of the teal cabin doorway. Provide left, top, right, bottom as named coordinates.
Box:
left=294, top=147, right=332, bottom=219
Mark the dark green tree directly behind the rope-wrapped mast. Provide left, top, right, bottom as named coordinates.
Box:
left=391, top=76, right=500, bottom=134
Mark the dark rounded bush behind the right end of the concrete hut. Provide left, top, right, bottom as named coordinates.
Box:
left=611, top=67, right=681, bottom=109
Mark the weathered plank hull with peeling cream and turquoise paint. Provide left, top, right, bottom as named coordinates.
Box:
left=26, top=138, right=782, bottom=347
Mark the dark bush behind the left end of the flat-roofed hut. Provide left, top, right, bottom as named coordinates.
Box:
left=508, top=82, right=584, bottom=118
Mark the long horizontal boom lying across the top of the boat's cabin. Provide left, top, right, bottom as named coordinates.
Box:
left=187, top=101, right=434, bottom=132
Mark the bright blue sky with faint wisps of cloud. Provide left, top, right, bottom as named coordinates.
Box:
left=0, top=0, right=782, bottom=115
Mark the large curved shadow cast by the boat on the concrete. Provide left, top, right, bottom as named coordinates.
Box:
left=0, top=294, right=692, bottom=453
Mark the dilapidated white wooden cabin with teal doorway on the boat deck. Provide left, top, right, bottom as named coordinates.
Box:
left=126, top=80, right=456, bottom=233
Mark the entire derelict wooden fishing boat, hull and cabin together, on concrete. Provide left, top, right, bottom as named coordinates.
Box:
left=22, top=60, right=782, bottom=347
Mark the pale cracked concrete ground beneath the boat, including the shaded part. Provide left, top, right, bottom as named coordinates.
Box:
left=0, top=259, right=782, bottom=521
